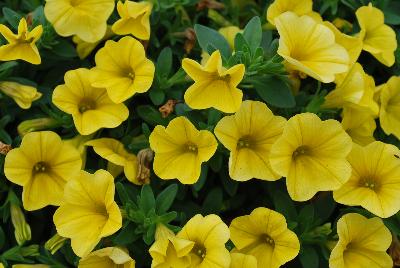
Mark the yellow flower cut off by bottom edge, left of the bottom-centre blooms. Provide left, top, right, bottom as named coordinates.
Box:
left=78, top=247, right=135, bottom=268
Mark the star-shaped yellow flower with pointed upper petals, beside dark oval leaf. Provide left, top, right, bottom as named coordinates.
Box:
left=182, top=50, right=245, bottom=113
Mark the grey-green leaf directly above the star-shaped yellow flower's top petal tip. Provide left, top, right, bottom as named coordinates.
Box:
left=194, top=24, right=231, bottom=59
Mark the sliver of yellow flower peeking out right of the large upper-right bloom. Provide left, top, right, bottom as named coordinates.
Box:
left=323, top=21, right=363, bottom=66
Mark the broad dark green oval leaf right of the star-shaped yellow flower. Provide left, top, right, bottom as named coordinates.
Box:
left=252, top=75, right=296, bottom=108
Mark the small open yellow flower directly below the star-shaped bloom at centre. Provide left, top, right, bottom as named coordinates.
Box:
left=149, top=116, right=218, bottom=184
